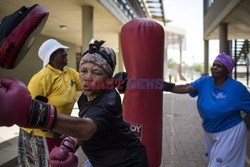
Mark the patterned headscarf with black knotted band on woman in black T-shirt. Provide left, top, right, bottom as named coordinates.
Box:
left=79, top=41, right=116, bottom=77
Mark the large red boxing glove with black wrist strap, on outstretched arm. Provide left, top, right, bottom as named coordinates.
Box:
left=0, top=78, right=56, bottom=130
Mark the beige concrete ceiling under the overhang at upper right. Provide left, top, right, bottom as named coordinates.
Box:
left=205, top=0, right=250, bottom=40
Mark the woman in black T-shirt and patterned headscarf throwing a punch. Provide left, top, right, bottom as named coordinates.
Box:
left=47, top=41, right=148, bottom=167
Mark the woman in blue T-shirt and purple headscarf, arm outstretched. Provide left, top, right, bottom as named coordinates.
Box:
left=163, top=53, right=250, bottom=167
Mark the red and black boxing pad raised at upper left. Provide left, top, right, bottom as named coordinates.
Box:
left=0, top=4, right=49, bottom=69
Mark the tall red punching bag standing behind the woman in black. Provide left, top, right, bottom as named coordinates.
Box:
left=121, top=19, right=164, bottom=167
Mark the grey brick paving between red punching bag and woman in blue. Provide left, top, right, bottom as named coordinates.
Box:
left=161, top=93, right=207, bottom=167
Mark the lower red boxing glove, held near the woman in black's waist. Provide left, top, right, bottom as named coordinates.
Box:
left=49, top=137, right=78, bottom=167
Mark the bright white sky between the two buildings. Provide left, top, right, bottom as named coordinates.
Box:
left=163, top=0, right=219, bottom=65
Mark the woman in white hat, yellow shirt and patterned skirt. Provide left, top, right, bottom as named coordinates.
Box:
left=18, top=39, right=82, bottom=166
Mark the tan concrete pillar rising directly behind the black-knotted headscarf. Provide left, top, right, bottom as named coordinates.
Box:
left=82, top=6, right=94, bottom=51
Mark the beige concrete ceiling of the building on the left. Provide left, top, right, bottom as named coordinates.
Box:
left=0, top=0, right=122, bottom=50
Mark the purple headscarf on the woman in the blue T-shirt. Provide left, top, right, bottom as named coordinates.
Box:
left=214, top=52, right=234, bottom=74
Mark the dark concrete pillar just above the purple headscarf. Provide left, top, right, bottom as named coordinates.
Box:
left=219, top=23, right=229, bottom=54
